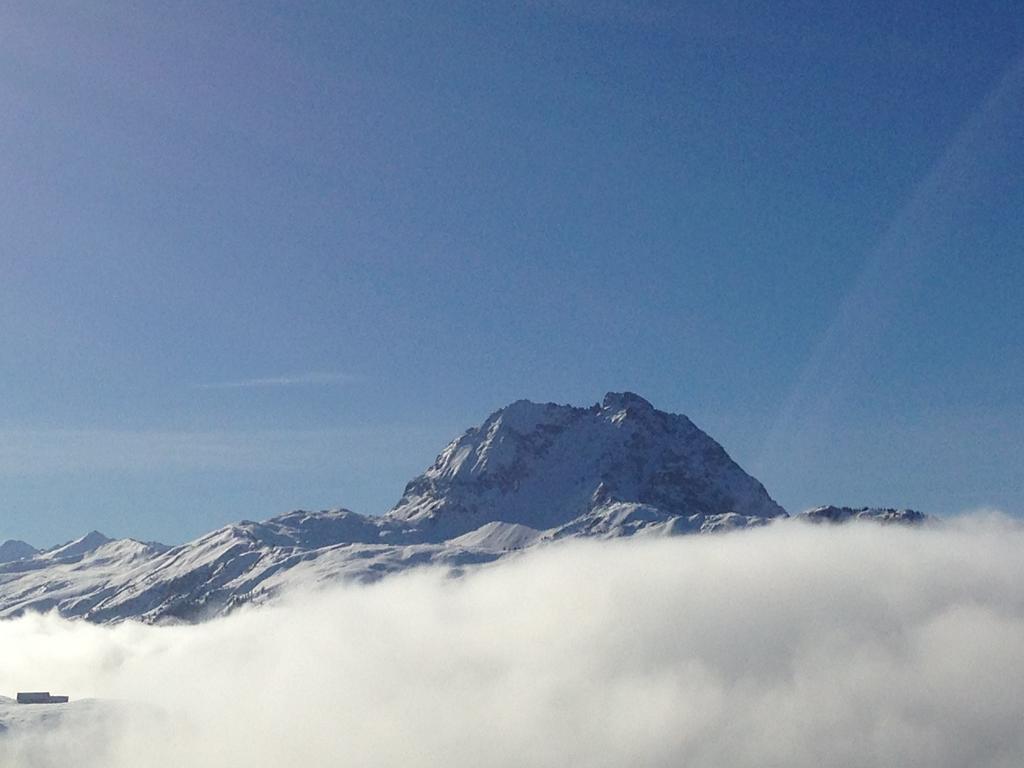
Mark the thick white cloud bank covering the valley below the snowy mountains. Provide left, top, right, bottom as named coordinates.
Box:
left=0, top=518, right=1024, bottom=768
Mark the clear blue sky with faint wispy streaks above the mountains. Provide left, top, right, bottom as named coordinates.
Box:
left=0, top=0, right=1024, bottom=545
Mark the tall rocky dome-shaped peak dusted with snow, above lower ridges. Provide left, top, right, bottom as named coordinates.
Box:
left=388, top=392, right=785, bottom=541
